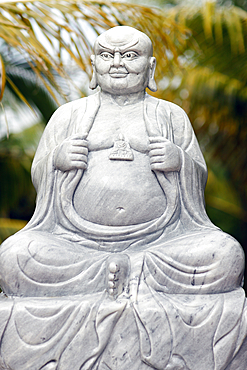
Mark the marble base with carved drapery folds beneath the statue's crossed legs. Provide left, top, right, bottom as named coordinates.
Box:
left=0, top=288, right=247, bottom=370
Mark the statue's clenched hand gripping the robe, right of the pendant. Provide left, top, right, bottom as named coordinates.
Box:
left=148, top=136, right=181, bottom=172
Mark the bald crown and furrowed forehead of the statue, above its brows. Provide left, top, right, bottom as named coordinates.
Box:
left=94, top=26, right=153, bottom=57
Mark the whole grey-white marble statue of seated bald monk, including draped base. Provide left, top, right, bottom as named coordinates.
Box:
left=0, top=27, right=247, bottom=370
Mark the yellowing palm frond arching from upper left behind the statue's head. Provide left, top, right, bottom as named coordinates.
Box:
left=0, top=0, right=188, bottom=104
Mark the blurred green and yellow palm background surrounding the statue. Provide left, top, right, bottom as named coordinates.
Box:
left=0, top=0, right=247, bottom=290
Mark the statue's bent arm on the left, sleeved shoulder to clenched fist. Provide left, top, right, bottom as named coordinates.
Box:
left=32, top=99, right=87, bottom=192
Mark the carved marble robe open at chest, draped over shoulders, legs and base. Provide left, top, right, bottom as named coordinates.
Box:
left=0, top=93, right=246, bottom=370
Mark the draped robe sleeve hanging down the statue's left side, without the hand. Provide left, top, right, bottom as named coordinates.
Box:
left=25, top=99, right=84, bottom=231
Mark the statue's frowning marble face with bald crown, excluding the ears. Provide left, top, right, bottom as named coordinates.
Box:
left=93, top=27, right=154, bottom=95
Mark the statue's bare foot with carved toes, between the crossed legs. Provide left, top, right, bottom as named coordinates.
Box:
left=107, top=254, right=129, bottom=299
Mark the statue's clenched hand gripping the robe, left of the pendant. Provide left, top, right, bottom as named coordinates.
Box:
left=54, top=134, right=88, bottom=171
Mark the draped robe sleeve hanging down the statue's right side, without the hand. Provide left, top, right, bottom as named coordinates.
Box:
left=158, top=102, right=216, bottom=229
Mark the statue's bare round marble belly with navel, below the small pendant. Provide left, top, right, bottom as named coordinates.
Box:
left=73, top=149, right=166, bottom=226
